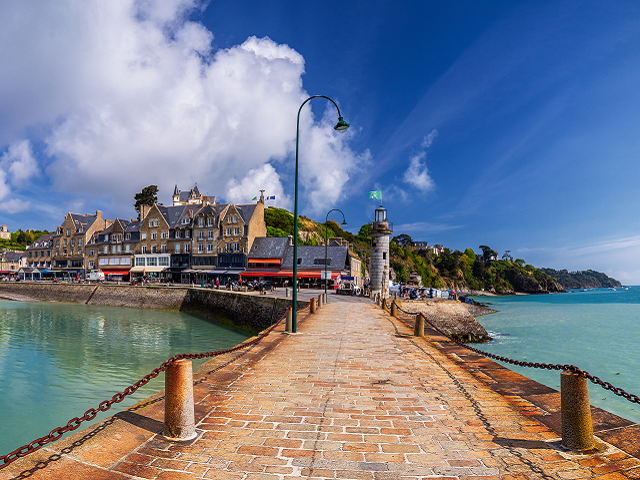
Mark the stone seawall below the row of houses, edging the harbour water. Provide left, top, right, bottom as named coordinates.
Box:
left=0, top=282, right=307, bottom=332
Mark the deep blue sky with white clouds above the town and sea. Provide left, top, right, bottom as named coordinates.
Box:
left=0, top=0, right=640, bottom=285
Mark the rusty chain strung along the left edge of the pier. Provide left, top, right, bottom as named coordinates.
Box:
left=0, top=306, right=286, bottom=470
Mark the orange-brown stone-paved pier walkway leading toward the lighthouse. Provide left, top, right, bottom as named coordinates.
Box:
left=0, top=295, right=640, bottom=480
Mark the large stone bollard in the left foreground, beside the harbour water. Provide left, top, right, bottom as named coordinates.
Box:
left=163, top=358, right=197, bottom=441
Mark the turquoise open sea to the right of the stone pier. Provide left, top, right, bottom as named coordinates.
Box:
left=476, top=287, right=640, bottom=422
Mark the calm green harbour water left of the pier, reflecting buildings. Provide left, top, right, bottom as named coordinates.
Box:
left=0, top=300, right=247, bottom=455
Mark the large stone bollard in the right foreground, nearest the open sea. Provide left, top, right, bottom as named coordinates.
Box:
left=560, top=370, right=596, bottom=450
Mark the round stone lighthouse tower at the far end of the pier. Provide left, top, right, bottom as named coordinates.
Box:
left=369, top=205, right=393, bottom=297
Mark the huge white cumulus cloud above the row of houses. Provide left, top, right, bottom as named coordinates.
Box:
left=0, top=0, right=362, bottom=217
